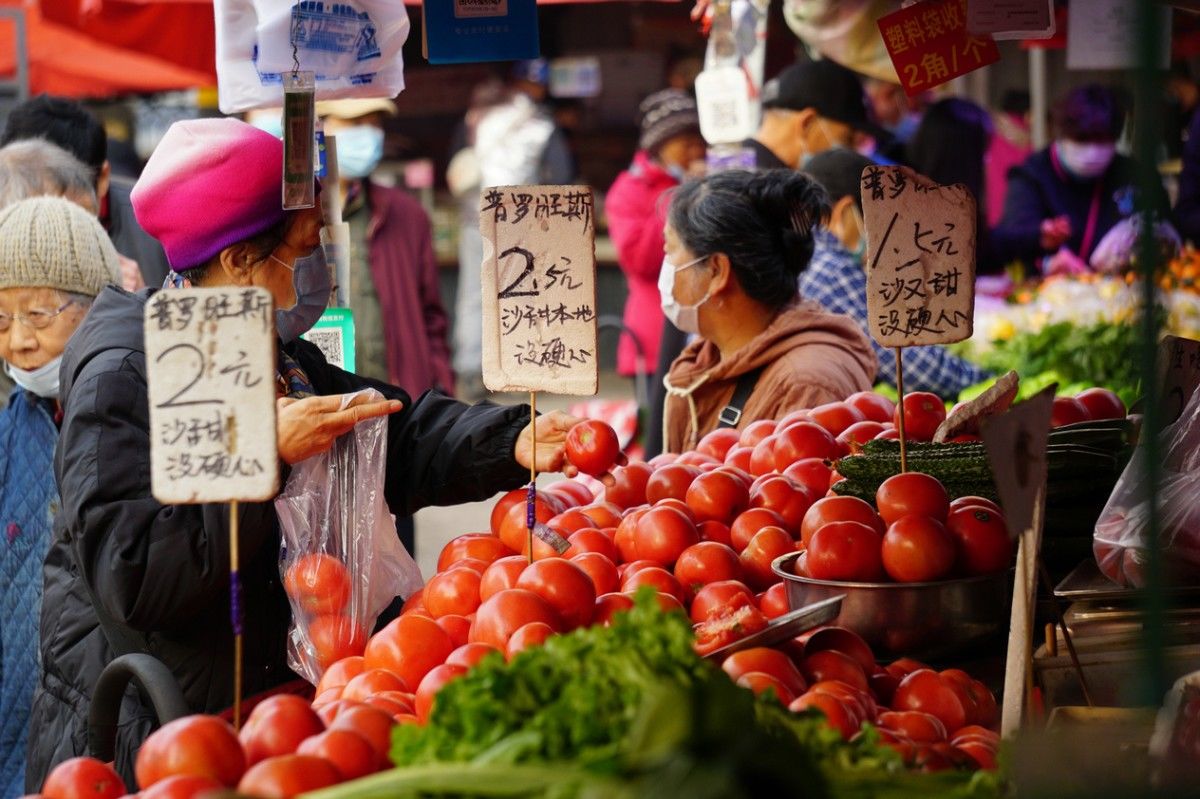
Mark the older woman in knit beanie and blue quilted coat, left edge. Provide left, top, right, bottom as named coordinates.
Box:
left=0, top=191, right=118, bottom=797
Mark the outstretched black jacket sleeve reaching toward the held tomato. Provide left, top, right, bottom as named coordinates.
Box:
left=296, top=341, right=529, bottom=516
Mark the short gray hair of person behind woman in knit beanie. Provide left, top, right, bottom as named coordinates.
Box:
left=0, top=139, right=100, bottom=215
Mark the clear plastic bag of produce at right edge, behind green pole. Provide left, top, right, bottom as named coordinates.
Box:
left=1092, top=391, right=1200, bottom=588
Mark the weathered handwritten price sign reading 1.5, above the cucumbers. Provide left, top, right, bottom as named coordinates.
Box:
left=862, top=166, right=976, bottom=347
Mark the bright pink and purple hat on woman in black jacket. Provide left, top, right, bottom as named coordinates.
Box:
left=130, top=119, right=284, bottom=272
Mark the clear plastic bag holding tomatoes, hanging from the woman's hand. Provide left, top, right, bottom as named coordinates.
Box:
left=275, top=389, right=422, bottom=685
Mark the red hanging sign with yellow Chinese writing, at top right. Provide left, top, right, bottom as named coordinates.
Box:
left=878, top=0, right=1000, bottom=97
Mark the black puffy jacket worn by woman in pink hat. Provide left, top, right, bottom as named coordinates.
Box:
left=25, top=287, right=528, bottom=793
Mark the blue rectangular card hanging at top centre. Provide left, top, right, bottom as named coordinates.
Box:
left=421, top=0, right=541, bottom=64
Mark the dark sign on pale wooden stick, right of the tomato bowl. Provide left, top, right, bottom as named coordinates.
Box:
left=983, top=386, right=1055, bottom=735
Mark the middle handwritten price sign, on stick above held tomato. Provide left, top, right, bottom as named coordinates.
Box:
left=479, top=186, right=599, bottom=395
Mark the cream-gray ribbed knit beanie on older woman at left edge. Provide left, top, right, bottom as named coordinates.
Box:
left=0, top=197, right=120, bottom=296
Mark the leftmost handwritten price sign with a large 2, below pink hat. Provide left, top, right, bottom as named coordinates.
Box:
left=145, top=288, right=278, bottom=504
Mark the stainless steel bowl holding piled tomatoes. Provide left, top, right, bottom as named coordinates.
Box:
left=772, top=552, right=1013, bottom=660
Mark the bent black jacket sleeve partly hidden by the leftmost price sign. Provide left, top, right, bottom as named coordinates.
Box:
left=58, top=368, right=275, bottom=631
